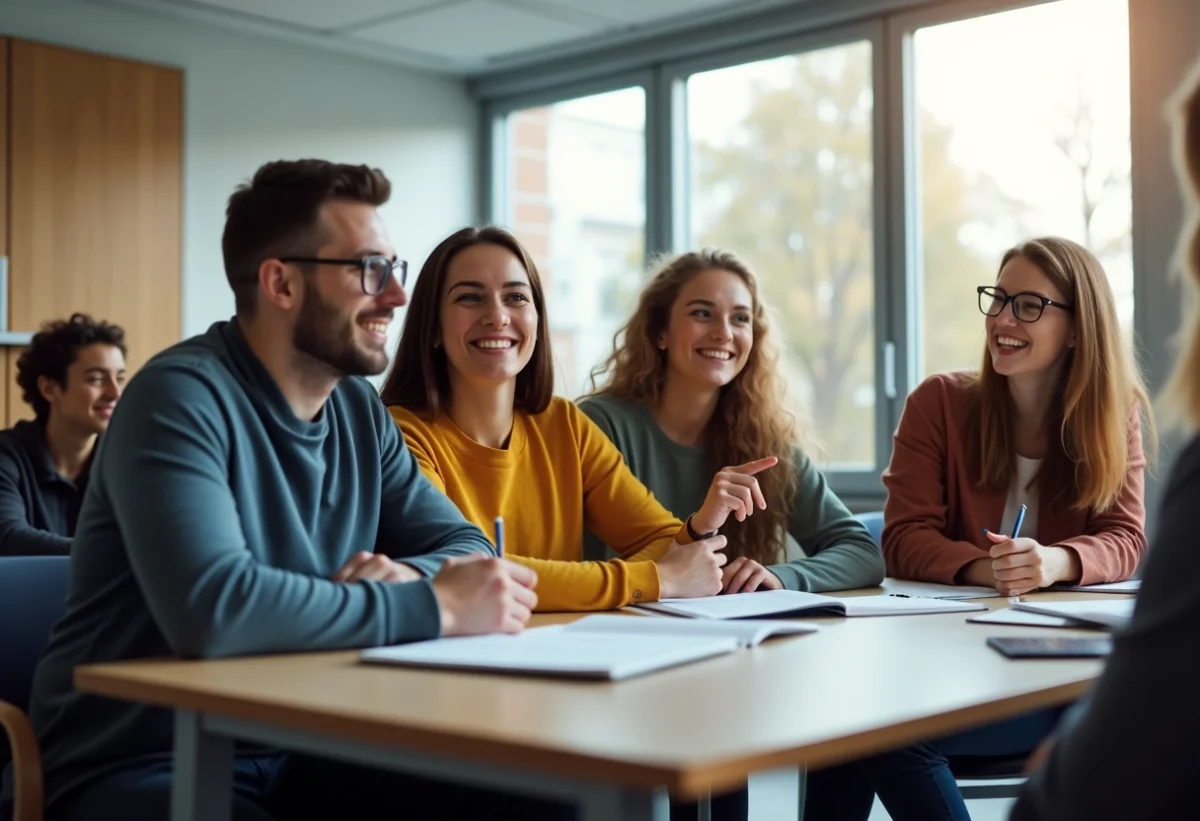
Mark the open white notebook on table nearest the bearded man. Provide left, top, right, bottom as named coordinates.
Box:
left=360, top=615, right=817, bottom=681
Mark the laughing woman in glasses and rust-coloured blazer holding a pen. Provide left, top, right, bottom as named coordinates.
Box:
left=806, top=238, right=1154, bottom=821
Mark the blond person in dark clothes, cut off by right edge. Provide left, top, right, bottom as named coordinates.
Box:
left=1010, top=54, right=1200, bottom=821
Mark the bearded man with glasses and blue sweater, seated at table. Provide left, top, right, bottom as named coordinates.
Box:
left=0, top=160, right=574, bottom=821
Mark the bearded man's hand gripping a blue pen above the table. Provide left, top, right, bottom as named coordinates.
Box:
left=433, top=553, right=538, bottom=636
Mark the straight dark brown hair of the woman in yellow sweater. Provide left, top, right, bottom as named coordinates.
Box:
left=379, top=226, right=554, bottom=419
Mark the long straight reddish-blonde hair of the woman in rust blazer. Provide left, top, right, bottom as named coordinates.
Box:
left=965, top=236, right=1156, bottom=511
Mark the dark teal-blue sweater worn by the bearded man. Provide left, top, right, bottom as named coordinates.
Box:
left=6, top=323, right=492, bottom=807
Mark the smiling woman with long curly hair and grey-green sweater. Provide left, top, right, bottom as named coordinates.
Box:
left=580, top=248, right=883, bottom=821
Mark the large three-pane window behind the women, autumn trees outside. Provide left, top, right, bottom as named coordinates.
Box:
left=476, top=0, right=1137, bottom=502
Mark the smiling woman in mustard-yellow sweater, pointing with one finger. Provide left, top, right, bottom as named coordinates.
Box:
left=382, top=227, right=775, bottom=611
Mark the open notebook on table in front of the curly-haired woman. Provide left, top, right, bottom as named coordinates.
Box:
left=637, top=591, right=986, bottom=619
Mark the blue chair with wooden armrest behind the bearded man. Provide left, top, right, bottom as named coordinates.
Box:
left=0, top=556, right=70, bottom=821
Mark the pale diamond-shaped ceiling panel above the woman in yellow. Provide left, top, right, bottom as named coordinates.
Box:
left=354, top=0, right=605, bottom=66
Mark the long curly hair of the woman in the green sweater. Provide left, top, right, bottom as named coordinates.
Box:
left=592, top=248, right=799, bottom=564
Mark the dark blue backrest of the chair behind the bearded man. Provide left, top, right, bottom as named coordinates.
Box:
left=0, top=556, right=70, bottom=771
